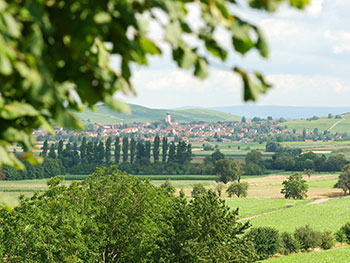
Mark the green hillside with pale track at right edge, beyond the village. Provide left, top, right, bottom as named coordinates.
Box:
left=281, top=113, right=350, bottom=133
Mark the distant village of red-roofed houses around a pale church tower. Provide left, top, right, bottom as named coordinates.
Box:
left=33, top=113, right=342, bottom=143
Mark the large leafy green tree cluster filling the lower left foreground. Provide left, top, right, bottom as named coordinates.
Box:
left=0, top=168, right=257, bottom=263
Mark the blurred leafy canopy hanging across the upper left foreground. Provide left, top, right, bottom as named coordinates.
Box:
left=0, top=0, right=309, bottom=168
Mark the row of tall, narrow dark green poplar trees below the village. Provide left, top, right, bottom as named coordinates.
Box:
left=41, top=136, right=192, bottom=168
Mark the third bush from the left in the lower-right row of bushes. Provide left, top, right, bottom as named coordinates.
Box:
left=294, top=225, right=322, bottom=250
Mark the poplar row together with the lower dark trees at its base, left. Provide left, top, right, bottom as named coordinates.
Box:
left=3, top=136, right=197, bottom=180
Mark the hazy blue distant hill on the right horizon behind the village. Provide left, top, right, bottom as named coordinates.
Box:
left=210, top=105, right=350, bottom=120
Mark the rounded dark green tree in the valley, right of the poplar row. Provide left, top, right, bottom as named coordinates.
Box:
left=215, top=159, right=243, bottom=184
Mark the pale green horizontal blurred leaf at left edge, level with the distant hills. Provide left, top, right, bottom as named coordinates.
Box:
left=0, top=102, right=39, bottom=120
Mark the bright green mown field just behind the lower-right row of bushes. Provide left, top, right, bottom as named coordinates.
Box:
left=251, top=197, right=350, bottom=232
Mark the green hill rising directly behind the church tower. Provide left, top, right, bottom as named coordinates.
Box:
left=78, top=104, right=241, bottom=124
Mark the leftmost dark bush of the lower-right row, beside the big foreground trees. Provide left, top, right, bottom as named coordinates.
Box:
left=246, top=227, right=280, bottom=259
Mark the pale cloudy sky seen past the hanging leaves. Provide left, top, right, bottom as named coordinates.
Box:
left=114, top=0, right=350, bottom=108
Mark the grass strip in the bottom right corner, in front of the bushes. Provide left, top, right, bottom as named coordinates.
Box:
left=260, top=247, right=350, bottom=263
